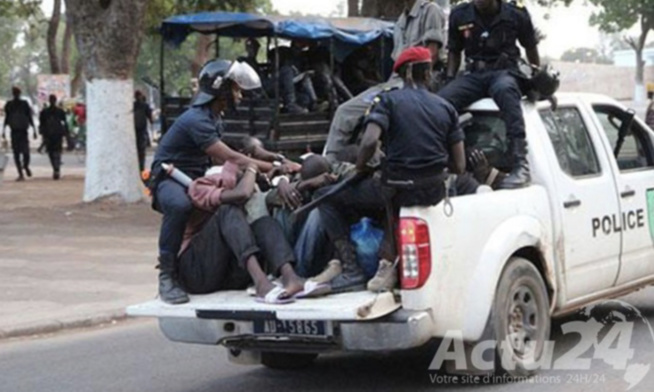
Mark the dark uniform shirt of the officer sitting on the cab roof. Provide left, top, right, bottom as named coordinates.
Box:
left=448, top=1, right=538, bottom=63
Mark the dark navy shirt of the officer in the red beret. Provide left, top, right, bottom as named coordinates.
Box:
left=365, top=87, right=464, bottom=174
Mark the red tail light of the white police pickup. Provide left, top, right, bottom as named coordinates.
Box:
left=399, top=218, right=431, bottom=290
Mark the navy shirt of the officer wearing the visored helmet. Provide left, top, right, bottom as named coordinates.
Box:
left=152, top=106, right=223, bottom=178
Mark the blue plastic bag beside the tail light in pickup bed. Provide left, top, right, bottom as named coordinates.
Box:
left=350, top=218, right=384, bottom=279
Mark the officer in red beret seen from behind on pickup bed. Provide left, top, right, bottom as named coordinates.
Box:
left=319, top=47, right=465, bottom=291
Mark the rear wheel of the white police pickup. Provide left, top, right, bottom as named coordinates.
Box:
left=492, top=257, right=551, bottom=377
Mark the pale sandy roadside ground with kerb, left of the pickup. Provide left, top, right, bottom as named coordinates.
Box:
left=0, top=161, right=160, bottom=338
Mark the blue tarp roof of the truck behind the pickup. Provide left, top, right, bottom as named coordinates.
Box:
left=161, top=12, right=393, bottom=46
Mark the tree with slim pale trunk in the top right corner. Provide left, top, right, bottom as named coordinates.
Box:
left=590, top=0, right=654, bottom=102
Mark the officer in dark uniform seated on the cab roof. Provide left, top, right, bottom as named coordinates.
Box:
left=438, top=0, right=540, bottom=189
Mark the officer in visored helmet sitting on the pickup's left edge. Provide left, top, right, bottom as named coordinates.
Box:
left=151, top=59, right=284, bottom=304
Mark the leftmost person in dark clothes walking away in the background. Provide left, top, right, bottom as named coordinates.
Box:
left=2, top=87, right=37, bottom=181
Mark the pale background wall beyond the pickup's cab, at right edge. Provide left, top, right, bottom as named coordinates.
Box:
left=552, top=61, right=654, bottom=100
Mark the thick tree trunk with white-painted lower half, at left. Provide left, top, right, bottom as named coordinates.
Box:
left=66, top=0, right=147, bottom=202
